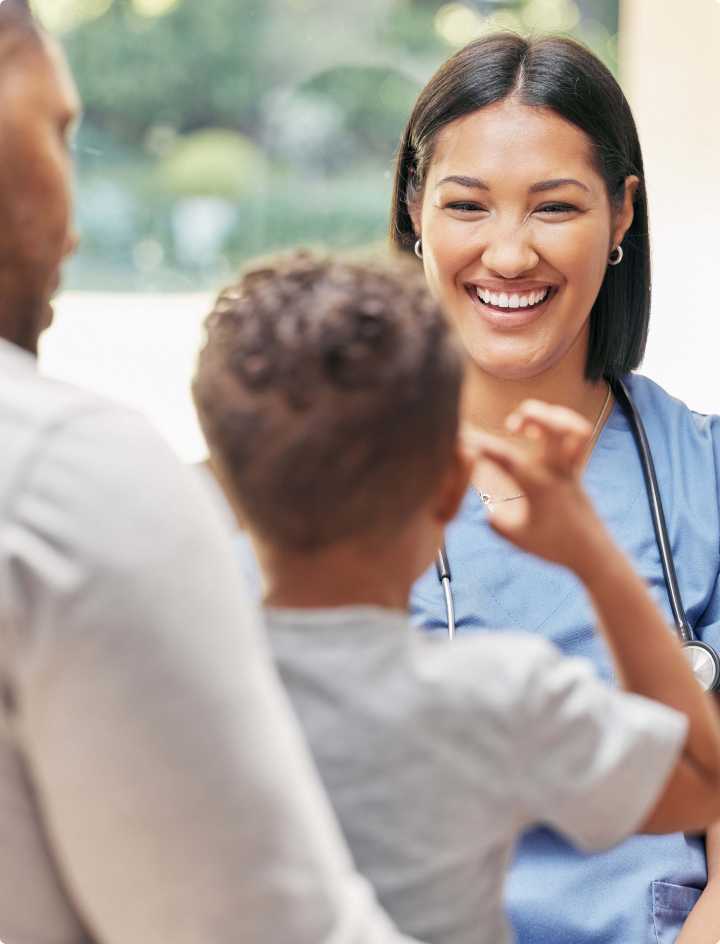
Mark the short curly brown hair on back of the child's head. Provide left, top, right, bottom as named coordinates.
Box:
left=193, top=251, right=463, bottom=551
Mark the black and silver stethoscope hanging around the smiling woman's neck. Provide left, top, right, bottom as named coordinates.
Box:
left=435, top=379, right=720, bottom=692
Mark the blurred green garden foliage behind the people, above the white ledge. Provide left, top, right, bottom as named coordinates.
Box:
left=50, top=0, right=617, bottom=291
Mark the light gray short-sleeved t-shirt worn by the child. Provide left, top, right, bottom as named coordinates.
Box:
left=266, top=607, right=687, bottom=944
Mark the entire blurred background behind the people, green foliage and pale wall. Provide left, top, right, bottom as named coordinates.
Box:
left=34, top=0, right=720, bottom=459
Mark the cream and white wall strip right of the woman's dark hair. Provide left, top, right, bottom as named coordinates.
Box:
left=620, top=0, right=720, bottom=413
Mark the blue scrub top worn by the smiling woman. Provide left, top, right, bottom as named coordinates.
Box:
left=411, top=375, right=720, bottom=944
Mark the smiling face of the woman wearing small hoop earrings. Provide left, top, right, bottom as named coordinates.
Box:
left=412, top=100, right=637, bottom=380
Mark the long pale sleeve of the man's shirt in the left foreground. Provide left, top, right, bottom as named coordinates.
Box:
left=2, top=411, right=416, bottom=944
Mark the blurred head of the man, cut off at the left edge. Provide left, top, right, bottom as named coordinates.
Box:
left=0, top=0, right=79, bottom=353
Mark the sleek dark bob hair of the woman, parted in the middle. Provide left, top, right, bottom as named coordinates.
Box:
left=390, top=33, right=650, bottom=380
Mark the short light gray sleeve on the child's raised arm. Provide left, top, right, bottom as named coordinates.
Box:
left=517, top=640, right=687, bottom=851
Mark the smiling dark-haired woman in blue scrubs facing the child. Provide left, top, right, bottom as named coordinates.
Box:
left=391, top=34, right=720, bottom=944
